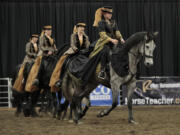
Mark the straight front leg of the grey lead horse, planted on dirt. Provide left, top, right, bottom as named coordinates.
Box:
left=127, top=79, right=137, bottom=124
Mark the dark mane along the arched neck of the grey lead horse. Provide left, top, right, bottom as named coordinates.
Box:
left=116, top=32, right=147, bottom=52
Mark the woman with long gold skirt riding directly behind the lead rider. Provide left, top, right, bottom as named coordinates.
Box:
left=49, top=23, right=90, bottom=91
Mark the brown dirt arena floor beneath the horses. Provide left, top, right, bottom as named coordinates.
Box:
left=0, top=106, right=180, bottom=135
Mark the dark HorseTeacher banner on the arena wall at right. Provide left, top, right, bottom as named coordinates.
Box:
left=123, top=77, right=180, bottom=105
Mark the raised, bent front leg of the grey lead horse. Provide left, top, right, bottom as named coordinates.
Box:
left=97, top=81, right=121, bottom=117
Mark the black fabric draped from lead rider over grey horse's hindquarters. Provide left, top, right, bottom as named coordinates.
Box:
left=67, top=43, right=111, bottom=85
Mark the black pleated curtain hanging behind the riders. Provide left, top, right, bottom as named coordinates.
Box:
left=0, top=0, right=180, bottom=78
